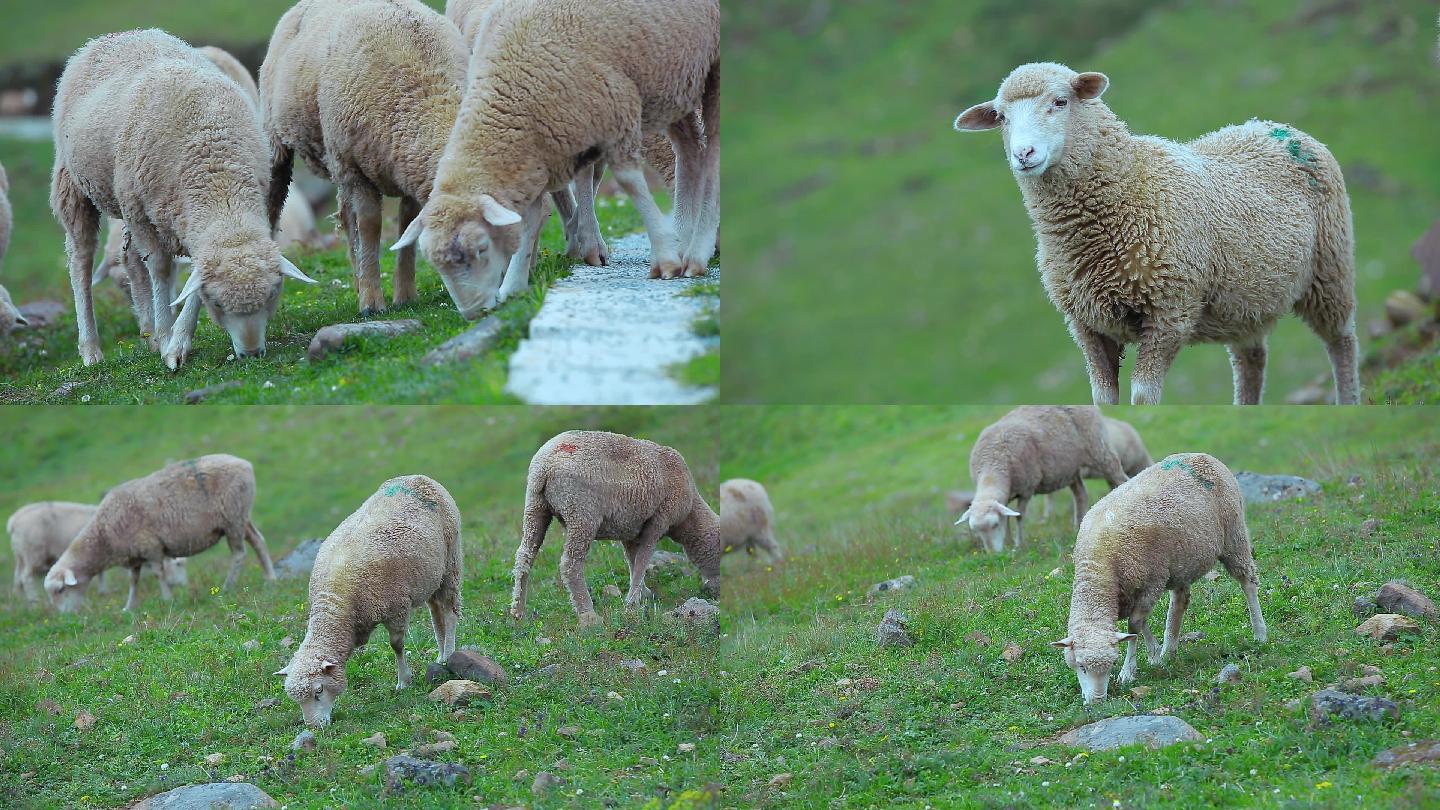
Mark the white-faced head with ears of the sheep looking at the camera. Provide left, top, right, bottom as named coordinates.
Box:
left=955, top=63, right=1110, bottom=177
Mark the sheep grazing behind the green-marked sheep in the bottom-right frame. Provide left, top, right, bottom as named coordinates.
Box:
left=955, top=405, right=1129, bottom=553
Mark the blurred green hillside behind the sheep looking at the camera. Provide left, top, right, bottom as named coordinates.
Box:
left=724, top=0, right=1440, bottom=404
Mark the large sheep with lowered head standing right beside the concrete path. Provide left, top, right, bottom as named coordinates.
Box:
left=393, top=0, right=720, bottom=319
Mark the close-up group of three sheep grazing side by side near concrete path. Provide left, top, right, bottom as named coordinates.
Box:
left=29, top=0, right=720, bottom=370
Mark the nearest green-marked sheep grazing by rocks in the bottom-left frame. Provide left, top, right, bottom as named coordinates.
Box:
left=275, top=476, right=461, bottom=726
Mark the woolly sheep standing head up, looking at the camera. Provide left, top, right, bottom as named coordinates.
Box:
left=955, top=62, right=1359, bottom=405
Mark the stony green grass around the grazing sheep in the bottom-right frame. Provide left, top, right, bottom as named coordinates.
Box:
left=717, top=406, right=1440, bottom=807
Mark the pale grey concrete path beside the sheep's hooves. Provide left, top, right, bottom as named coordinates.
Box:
left=505, top=233, right=720, bottom=405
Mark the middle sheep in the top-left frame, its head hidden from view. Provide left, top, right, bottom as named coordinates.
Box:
left=261, top=0, right=467, bottom=314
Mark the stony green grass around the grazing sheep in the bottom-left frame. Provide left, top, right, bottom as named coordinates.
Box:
left=0, top=406, right=729, bottom=807
